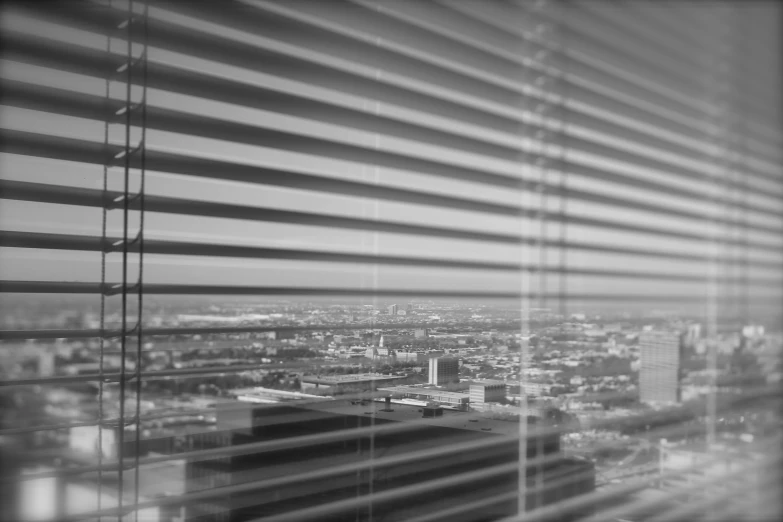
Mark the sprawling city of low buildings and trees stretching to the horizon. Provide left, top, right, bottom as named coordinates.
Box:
left=0, top=300, right=782, bottom=520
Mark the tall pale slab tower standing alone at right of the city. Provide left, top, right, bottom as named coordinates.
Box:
left=639, top=330, right=682, bottom=403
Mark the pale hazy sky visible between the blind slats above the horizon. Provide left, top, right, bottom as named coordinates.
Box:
left=0, top=2, right=783, bottom=318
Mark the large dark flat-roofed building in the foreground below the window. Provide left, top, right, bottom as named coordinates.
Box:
left=185, top=401, right=595, bottom=522
